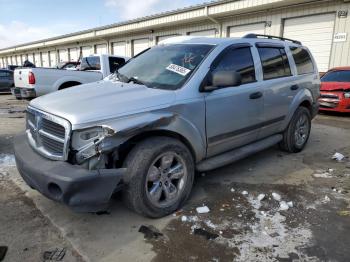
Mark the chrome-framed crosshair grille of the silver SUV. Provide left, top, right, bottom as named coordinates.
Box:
left=26, top=107, right=70, bottom=160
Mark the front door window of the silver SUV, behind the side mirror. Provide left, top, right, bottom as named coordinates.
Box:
left=214, top=47, right=256, bottom=85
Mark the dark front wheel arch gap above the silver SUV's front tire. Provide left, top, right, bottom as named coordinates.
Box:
left=109, top=130, right=196, bottom=168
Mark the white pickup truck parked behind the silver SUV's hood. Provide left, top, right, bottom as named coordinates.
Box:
left=11, top=55, right=129, bottom=99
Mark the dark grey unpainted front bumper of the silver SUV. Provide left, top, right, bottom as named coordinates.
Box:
left=14, top=134, right=126, bottom=212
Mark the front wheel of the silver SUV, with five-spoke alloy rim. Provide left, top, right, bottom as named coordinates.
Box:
left=123, top=137, right=195, bottom=218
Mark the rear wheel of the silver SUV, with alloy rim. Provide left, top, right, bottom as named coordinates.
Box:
left=279, top=106, right=311, bottom=153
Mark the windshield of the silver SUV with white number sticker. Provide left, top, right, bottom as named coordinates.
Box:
left=117, top=44, right=214, bottom=90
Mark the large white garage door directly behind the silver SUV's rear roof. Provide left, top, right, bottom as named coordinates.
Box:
left=283, top=14, right=335, bottom=72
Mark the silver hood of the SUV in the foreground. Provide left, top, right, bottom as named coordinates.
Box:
left=30, top=81, right=176, bottom=125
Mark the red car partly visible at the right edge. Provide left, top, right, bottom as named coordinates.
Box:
left=319, top=67, right=350, bottom=113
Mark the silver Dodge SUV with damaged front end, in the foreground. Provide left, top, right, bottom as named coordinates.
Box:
left=14, top=35, right=320, bottom=217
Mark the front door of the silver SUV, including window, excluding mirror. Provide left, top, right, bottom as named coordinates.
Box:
left=205, top=45, right=264, bottom=157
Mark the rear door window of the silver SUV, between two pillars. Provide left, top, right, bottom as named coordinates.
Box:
left=258, top=47, right=292, bottom=80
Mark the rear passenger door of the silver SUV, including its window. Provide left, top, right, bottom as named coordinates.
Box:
left=257, top=43, right=299, bottom=138
